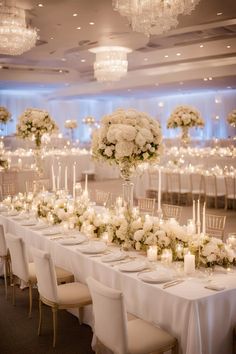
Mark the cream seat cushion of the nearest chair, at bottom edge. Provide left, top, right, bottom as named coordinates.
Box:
left=127, top=319, right=176, bottom=354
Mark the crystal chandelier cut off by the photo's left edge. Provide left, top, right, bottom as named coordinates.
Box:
left=0, top=3, right=37, bottom=55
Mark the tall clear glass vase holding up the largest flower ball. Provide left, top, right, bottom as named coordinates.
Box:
left=120, top=162, right=134, bottom=210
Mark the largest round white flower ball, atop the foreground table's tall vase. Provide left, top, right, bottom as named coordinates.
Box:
left=92, top=109, right=162, bottom=167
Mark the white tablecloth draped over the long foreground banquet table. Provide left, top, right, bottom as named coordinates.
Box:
left=0, top=215, right=236, bottom=354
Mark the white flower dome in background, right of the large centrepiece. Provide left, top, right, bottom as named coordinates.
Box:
left=167, top=106, right=205, bottom=128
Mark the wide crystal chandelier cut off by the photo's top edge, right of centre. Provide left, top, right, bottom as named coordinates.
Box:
left=112, top=0, right=200, bottom=36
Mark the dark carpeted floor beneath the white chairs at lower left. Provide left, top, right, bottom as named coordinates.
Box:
left=0, top=278, right=94, bottom=354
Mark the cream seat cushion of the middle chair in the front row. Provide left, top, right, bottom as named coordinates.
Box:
left=57, top=282, right=92, bottom=305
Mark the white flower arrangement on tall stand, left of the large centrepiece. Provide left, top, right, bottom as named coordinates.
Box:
left=16, top=108, right=57, bottom=147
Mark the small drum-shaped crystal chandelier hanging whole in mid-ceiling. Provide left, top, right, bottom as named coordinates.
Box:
left=90, top=46, right=132, bottom=82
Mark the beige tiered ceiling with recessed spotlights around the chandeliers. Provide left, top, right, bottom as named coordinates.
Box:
left=0, top=0, right=236, bottom=99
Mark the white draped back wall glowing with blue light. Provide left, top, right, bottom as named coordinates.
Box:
left=0, top=90, right=236, bottom=141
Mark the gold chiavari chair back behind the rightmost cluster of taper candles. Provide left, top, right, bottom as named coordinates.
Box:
left=206, top=213, right=226, bottom=240
